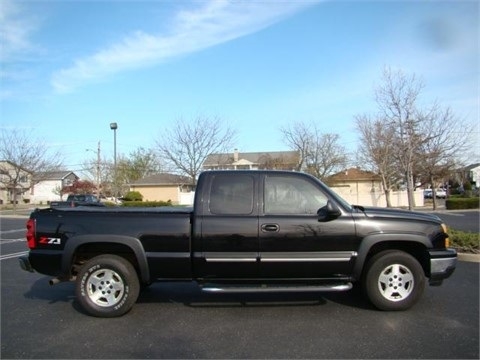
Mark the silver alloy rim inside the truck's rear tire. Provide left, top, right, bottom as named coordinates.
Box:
left=86, top=269, right=125, bottom=307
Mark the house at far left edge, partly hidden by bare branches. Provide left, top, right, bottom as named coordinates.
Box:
left=0, top=160, right=32, bottom=204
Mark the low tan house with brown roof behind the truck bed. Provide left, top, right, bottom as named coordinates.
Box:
left=130, top=173, right=193, bottom=205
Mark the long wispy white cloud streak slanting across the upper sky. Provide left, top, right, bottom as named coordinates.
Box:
left=51, top=0, right=315, bottom=92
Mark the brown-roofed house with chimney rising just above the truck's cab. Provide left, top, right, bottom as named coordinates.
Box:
left=202, top=149, right=299, bottom=170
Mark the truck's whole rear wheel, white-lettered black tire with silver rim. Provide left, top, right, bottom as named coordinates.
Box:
left=75, top=255, right=140, bottom=317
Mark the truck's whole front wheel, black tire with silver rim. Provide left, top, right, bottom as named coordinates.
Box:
left=362, top=250, right=425, bottom=311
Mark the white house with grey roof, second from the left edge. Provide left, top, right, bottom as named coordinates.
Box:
left=30, top=170, right=79, bottom=204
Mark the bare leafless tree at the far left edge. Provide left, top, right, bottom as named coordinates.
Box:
left=0, top=129, right=62, bottom=211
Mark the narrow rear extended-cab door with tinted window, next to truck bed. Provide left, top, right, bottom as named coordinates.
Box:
left=192, top=172, right=258, bottom=279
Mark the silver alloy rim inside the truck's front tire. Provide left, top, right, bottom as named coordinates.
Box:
left=378, top=264, right=415, bottom=302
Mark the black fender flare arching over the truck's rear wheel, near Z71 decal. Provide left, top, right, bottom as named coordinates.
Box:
left=62, top=234, right=150, bottom=283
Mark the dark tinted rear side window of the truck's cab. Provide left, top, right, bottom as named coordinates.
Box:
left=209, top=174, right=254, bottom=215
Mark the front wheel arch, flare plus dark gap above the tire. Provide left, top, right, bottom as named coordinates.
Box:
left=353, top=234, right=431, bottom=280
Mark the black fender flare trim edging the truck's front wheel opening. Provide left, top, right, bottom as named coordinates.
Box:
left=353, top=233, right=432, bottom=279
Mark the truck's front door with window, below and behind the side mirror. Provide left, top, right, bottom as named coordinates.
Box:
left=259, top=173, right=357, bottom=280
